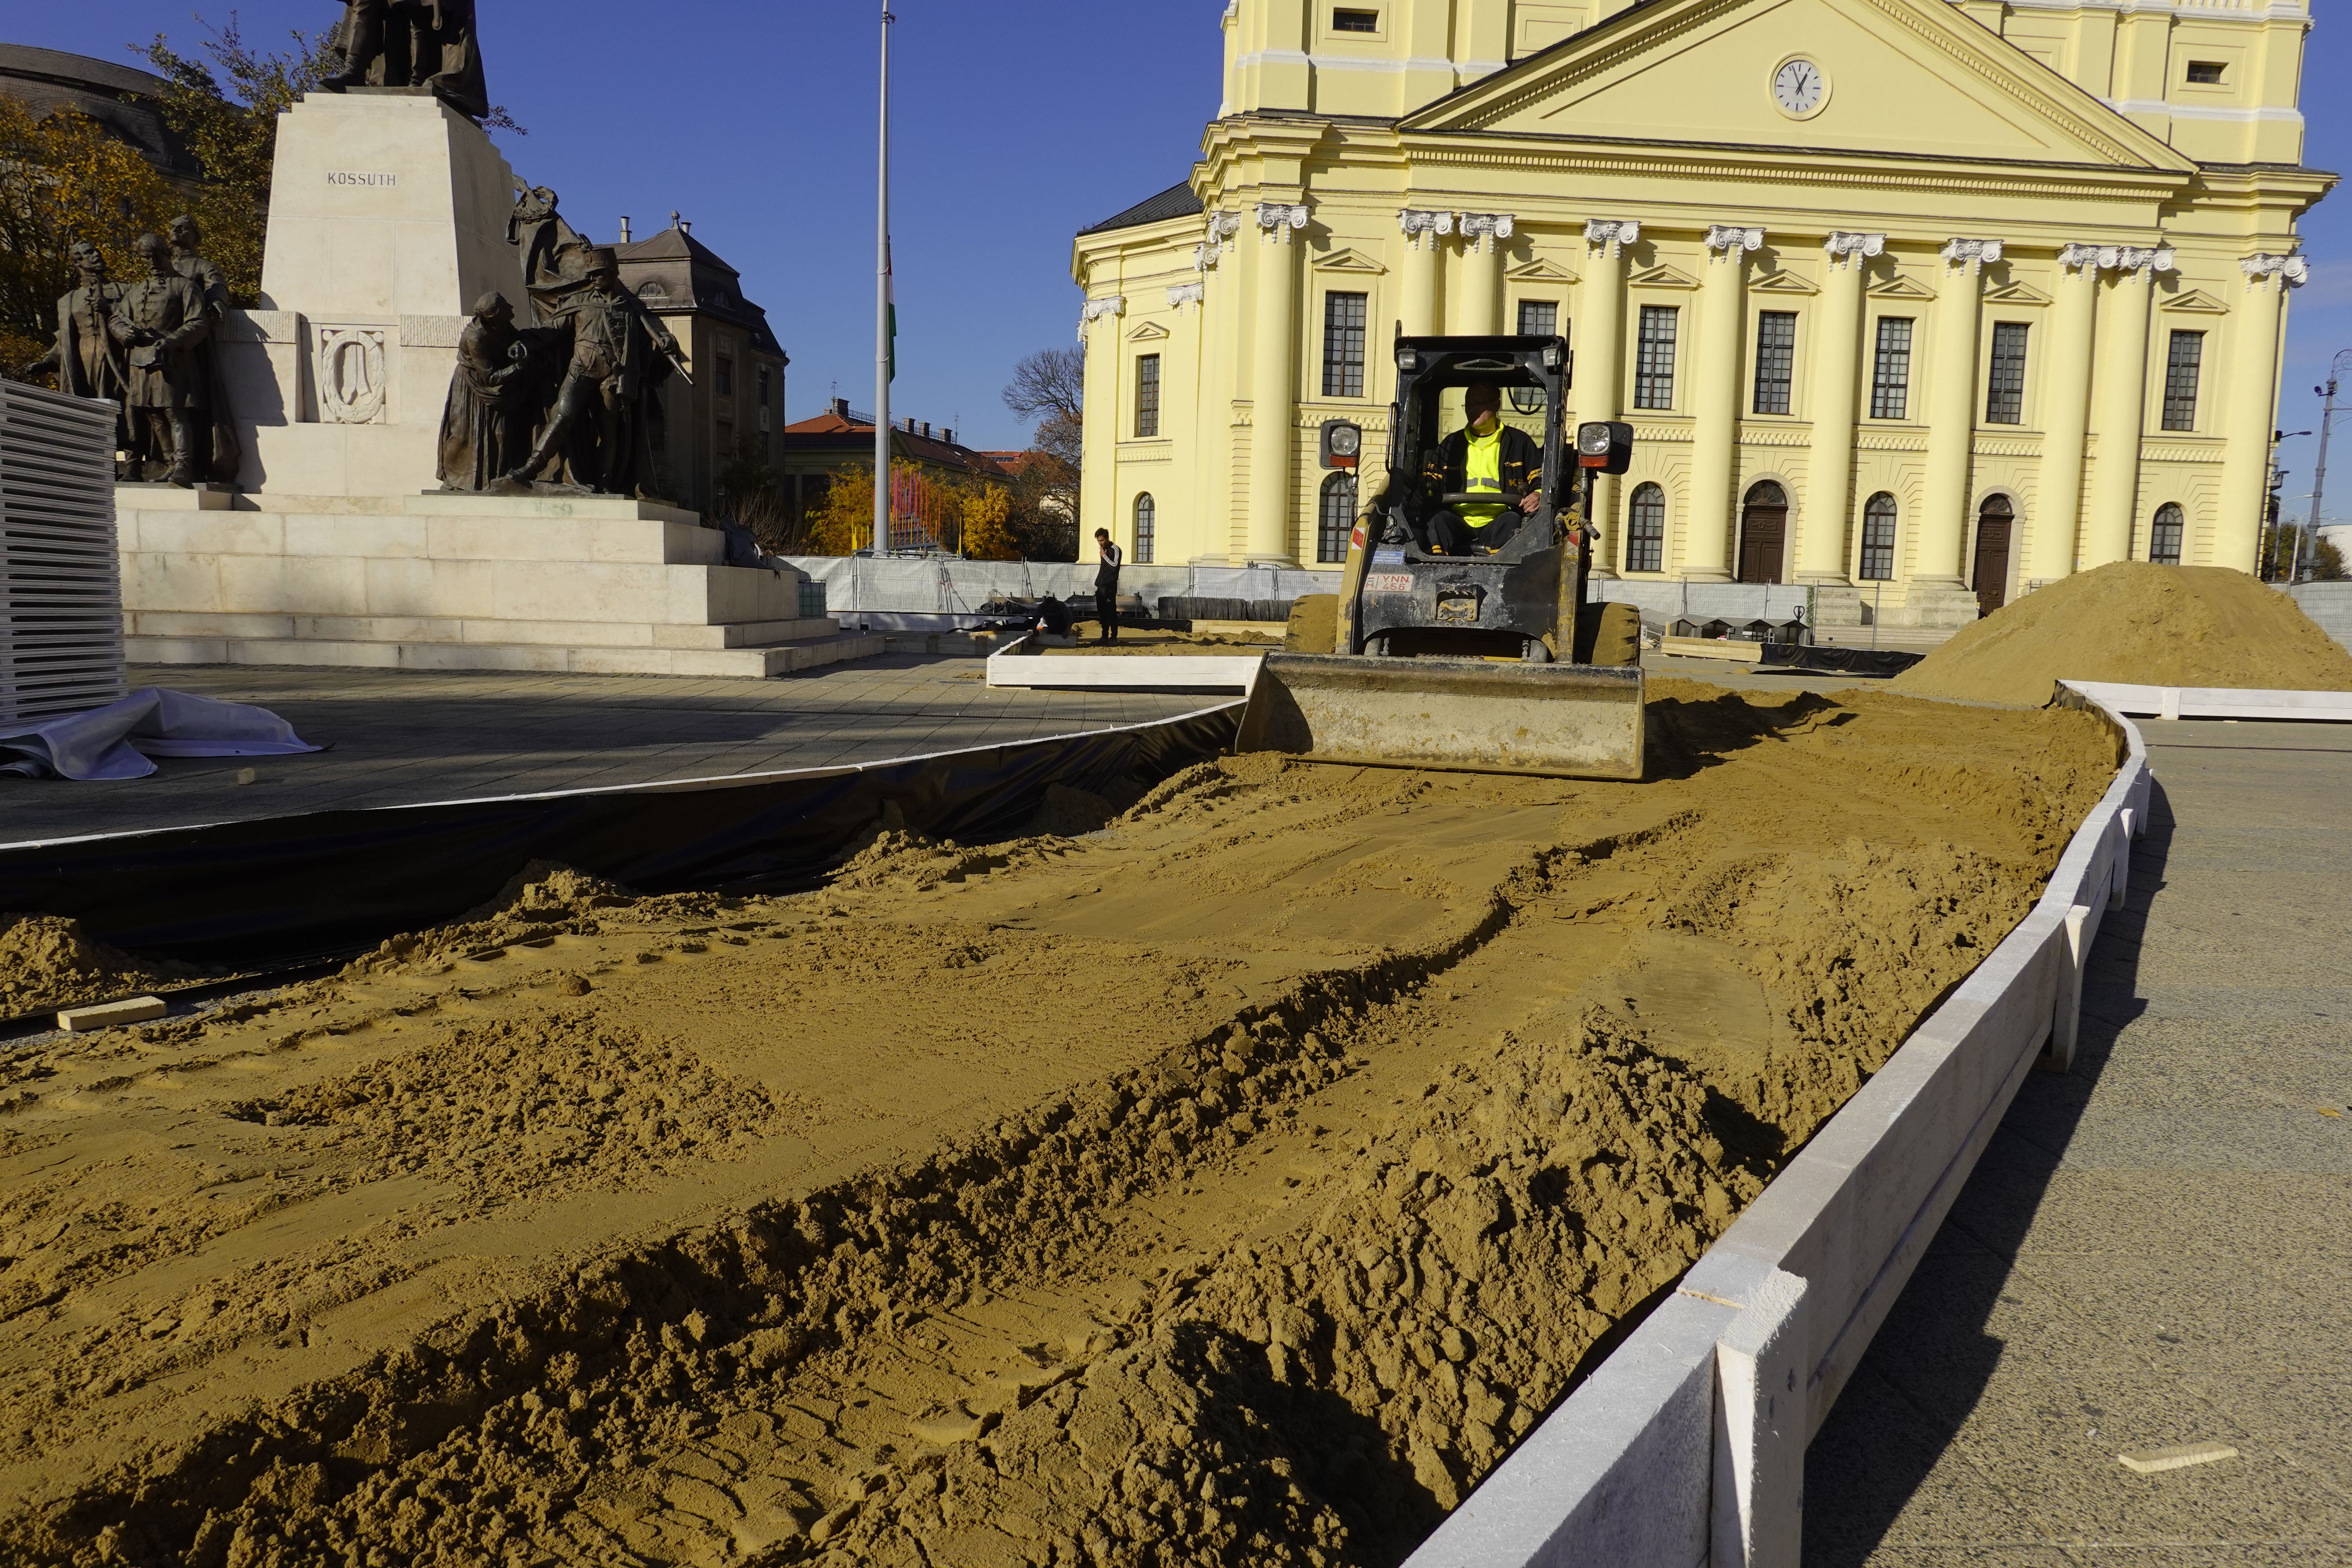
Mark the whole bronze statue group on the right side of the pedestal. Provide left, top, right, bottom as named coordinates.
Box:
left=440, top=186, right=689, bottom=498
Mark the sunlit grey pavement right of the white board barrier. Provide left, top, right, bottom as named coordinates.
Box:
left=1804, top=722, right=2352, bottom=1568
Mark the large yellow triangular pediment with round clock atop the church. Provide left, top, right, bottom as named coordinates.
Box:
left=1402, top=0, right=2197, bottom=174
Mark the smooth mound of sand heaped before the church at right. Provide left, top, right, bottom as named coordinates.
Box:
left=1893, top=562, right=2352, bottom=707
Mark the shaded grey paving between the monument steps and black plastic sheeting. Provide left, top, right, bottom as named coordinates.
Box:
left=0, top=656, right=1230, bottom=844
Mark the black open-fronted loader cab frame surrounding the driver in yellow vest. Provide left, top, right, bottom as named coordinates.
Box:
left=1378, top=336, right=1576, bottom=560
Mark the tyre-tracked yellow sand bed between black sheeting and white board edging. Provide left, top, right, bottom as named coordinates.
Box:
left=0, top=680, right=2114, bottom=1568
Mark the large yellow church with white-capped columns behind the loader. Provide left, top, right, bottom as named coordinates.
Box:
left=1072, top=0, right=2336, bottom=625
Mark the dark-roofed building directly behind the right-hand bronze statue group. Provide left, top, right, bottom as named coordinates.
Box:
left=614, top=211, right=790, bottom=512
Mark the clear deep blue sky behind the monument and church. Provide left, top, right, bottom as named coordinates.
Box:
left=18, top=0, right=2352, bottom=491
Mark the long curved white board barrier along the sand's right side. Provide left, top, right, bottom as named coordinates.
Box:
left=1409, top=682, right=2154, bottom=1568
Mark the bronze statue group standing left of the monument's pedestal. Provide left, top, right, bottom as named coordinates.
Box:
left=24, top=214, right=240, bottom=484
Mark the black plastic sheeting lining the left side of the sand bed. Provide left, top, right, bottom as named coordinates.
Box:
left=0, top=703, right=1242, bottom=966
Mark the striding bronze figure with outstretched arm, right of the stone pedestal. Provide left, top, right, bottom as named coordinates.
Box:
left=505, top=245, right=684, bottom=496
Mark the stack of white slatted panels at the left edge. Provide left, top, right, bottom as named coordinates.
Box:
left=0, top=381, right=125, bottom=722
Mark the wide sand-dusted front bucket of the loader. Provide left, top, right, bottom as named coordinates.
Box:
left=1235, top=653, right=1642, bottom=778
